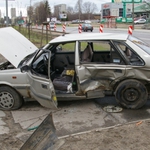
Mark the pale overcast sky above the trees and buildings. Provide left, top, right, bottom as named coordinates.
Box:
left=0, top=0, right=111, bottom=17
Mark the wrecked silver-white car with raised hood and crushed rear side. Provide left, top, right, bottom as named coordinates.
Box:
left=0, top=27, right=150, bottom=110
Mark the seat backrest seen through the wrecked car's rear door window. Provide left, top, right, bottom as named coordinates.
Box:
left=82, top=44, right=93, bottom=62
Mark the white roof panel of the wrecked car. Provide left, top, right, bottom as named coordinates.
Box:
left=50, top=33, right=129, bottom=43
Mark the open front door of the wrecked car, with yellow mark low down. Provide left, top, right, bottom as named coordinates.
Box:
left=27, top=50, right=57, bottom=109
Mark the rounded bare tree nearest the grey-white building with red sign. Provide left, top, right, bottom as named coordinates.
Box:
left=83, top=2, right=97, bottom=19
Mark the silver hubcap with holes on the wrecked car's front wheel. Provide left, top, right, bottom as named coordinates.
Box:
left=0, top=92, right=14, bottom=109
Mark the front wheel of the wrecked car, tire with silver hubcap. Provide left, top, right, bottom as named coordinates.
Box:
left=0, top=86, right=24, bottom=110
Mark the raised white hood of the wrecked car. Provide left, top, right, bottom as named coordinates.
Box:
left=0, top=27, right=38, bottom=68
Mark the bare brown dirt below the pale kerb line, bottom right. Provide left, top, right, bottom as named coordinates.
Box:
left=60, top=120, right=150, bottom=150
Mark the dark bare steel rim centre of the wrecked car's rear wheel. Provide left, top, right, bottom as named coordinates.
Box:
left=124, top=89, right=139, bottom=102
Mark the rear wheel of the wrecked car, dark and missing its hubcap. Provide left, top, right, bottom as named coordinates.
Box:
left=115, top=79, right=148, bottom=109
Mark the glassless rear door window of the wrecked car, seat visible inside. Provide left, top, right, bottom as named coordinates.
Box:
left=79, top=41, right=123, bottom=64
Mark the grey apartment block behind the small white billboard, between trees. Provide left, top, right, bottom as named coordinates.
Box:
left=54, top=4, right=67, bottom=20
